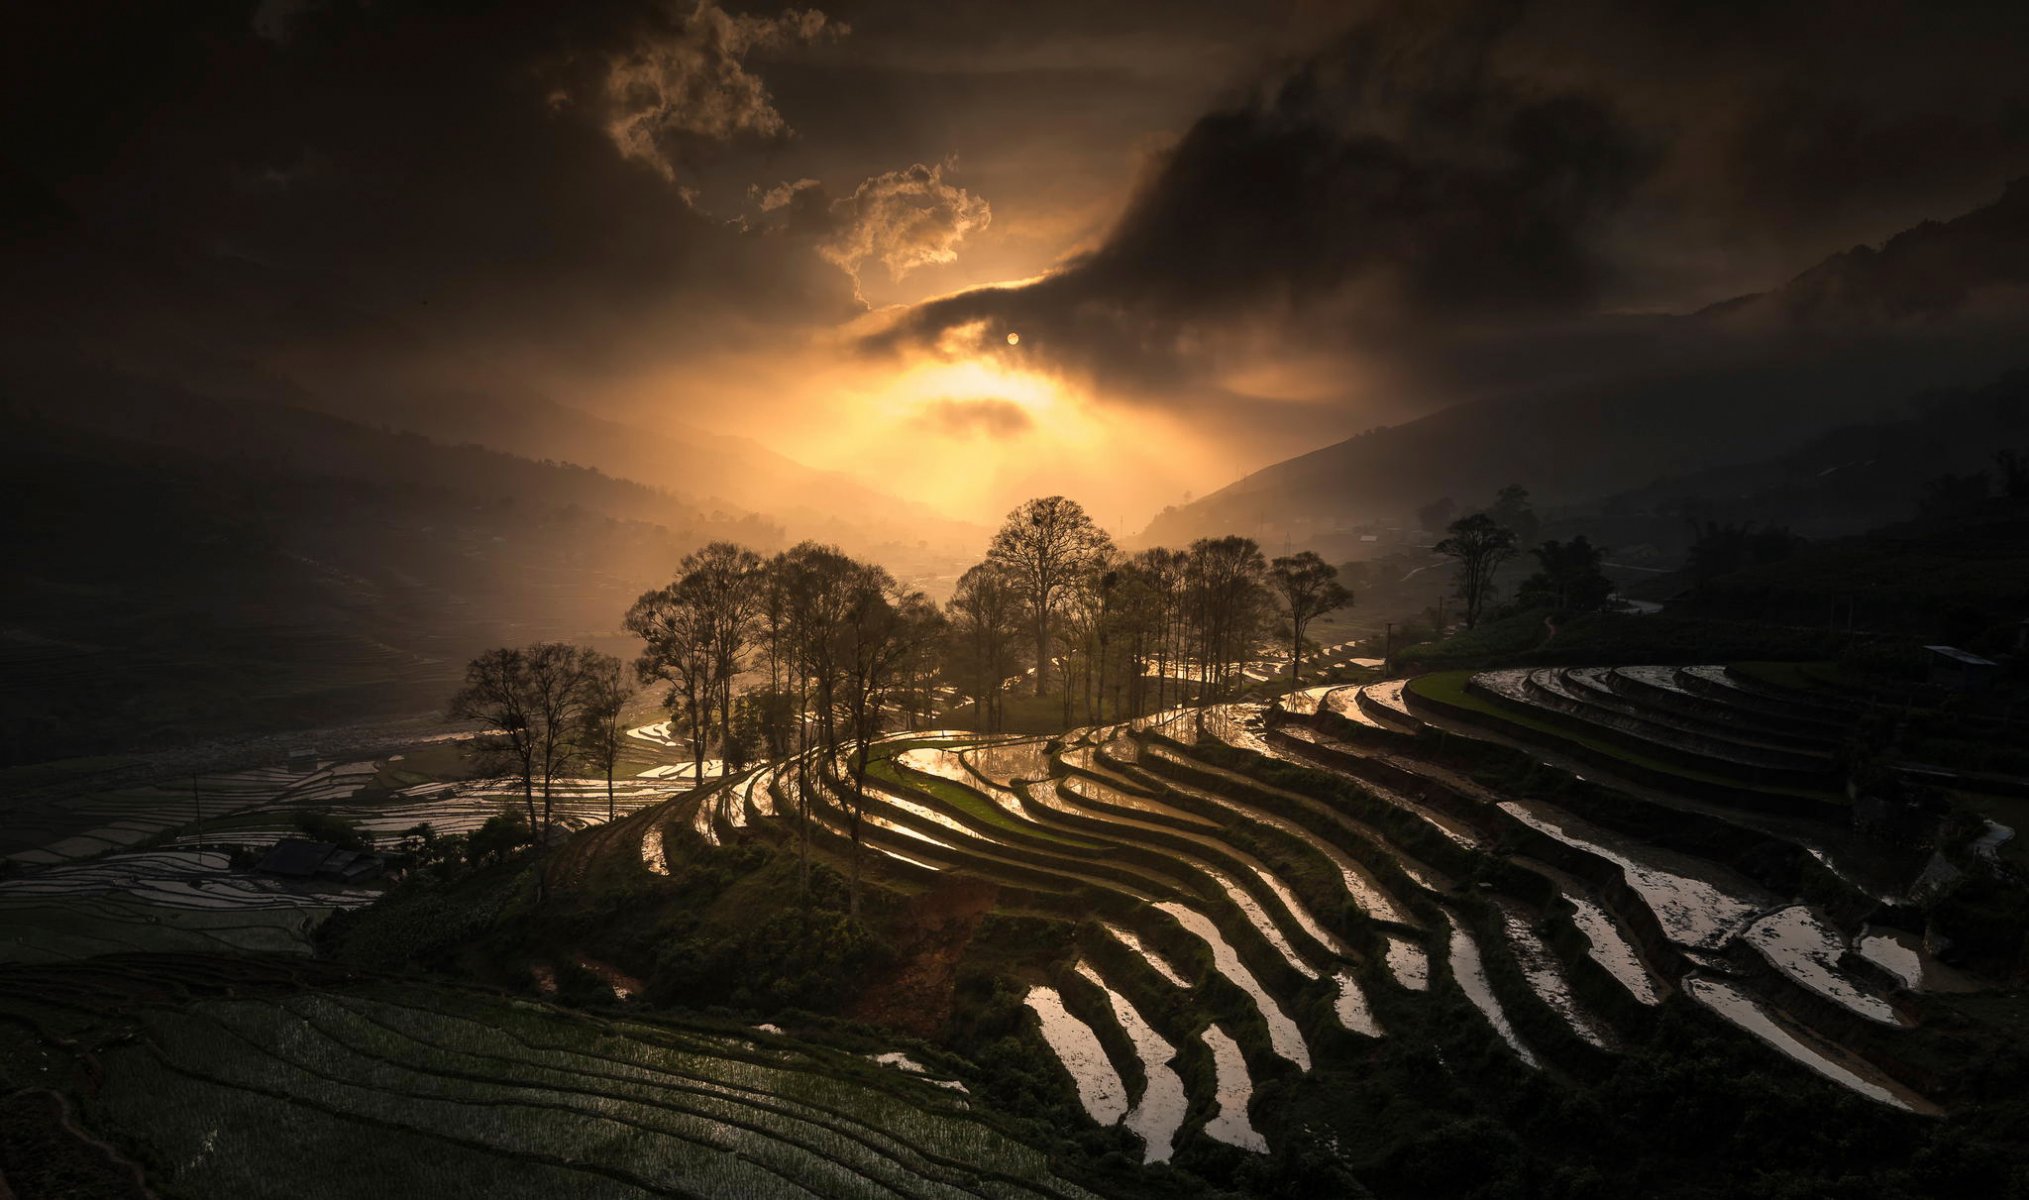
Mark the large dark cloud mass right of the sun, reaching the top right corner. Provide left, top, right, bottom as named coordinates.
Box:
left=864, top=0, right=2029, bottom=406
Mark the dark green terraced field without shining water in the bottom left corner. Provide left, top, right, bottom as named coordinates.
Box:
left=0, top=958, right=1092, bottom=1200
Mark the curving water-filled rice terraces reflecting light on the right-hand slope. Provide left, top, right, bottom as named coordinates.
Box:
left=645, top=670, right=1996, bottom=1161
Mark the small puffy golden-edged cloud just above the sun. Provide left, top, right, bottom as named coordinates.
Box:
left=749, top=162, right=994, bottom=303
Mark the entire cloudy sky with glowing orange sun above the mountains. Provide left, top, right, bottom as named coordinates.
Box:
left=0, top=0, right=2029, bottom=528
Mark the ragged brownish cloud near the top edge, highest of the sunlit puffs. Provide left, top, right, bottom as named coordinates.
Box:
left=605, top=0, right=850, bottom=181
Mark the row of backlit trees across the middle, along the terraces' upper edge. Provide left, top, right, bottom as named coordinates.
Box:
left=450, top=495, right=1353, bottom=906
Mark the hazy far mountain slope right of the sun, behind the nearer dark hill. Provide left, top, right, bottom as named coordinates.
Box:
left=1140, top=181, right=2029, bottom=544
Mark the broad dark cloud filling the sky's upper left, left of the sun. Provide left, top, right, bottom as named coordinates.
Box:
left=0, top=0, right=854, bottom=389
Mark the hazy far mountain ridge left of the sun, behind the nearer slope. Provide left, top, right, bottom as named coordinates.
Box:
left=0, top=201, right=988, bottom=554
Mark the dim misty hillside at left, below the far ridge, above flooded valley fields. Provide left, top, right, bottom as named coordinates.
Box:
left=0, top=382, right=762, bottom=761
